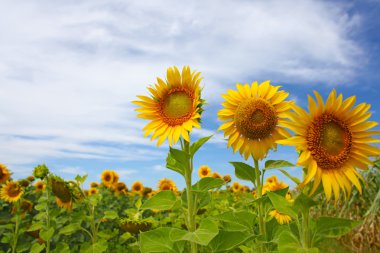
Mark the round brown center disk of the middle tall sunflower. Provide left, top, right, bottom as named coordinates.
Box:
left=235, top=98, right=277, bottom=140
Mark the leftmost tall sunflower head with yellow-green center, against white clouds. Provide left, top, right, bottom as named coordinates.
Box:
left=133, top=67, right=204, bottom=146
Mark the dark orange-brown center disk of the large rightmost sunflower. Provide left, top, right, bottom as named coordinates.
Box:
left=307, top=114, right=352, bottom=170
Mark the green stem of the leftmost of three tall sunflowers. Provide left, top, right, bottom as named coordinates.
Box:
left=183, top=141, right=198, bottom=253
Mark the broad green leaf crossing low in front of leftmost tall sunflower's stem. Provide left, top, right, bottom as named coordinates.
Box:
left=170, top=219, right=219, bottom=246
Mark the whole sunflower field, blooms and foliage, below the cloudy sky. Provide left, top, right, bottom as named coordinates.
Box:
left=0, top=66, right=380, bottom=253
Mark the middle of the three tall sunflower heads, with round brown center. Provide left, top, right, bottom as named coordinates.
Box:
left=218, top=81, right=293, bottom=160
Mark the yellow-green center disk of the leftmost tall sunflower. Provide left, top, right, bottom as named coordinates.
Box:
left=162, top=91, right=193, bottom=125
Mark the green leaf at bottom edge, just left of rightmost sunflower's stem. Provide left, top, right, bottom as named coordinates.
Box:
left=278, top=231, right=319, bottom=253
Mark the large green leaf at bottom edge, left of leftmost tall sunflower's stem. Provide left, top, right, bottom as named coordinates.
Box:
left=140, top=227, right=185, bottom=253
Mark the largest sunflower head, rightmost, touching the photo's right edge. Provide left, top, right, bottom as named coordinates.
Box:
left=278, top=89, right=380, bottom=200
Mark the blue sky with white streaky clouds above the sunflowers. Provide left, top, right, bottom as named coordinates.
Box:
left=0, top=0, right=380, bottom=190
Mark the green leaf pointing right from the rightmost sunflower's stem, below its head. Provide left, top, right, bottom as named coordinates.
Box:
left=315, top=217, right=363, bottom=238
